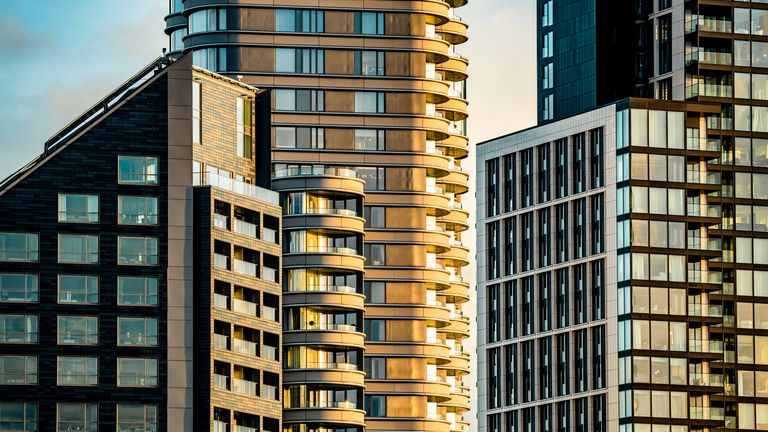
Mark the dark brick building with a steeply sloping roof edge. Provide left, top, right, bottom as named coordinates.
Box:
left=0, top=56, right=282, bottom=432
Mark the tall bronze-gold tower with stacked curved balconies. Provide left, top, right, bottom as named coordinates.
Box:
left=166, top=0, right=469, bottom=432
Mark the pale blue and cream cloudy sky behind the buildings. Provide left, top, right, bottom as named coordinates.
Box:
left=0, top=0, right=536, bottom=426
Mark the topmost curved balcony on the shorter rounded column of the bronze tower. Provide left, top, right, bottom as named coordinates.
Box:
left=272, top=167, right=365, bottom=195
